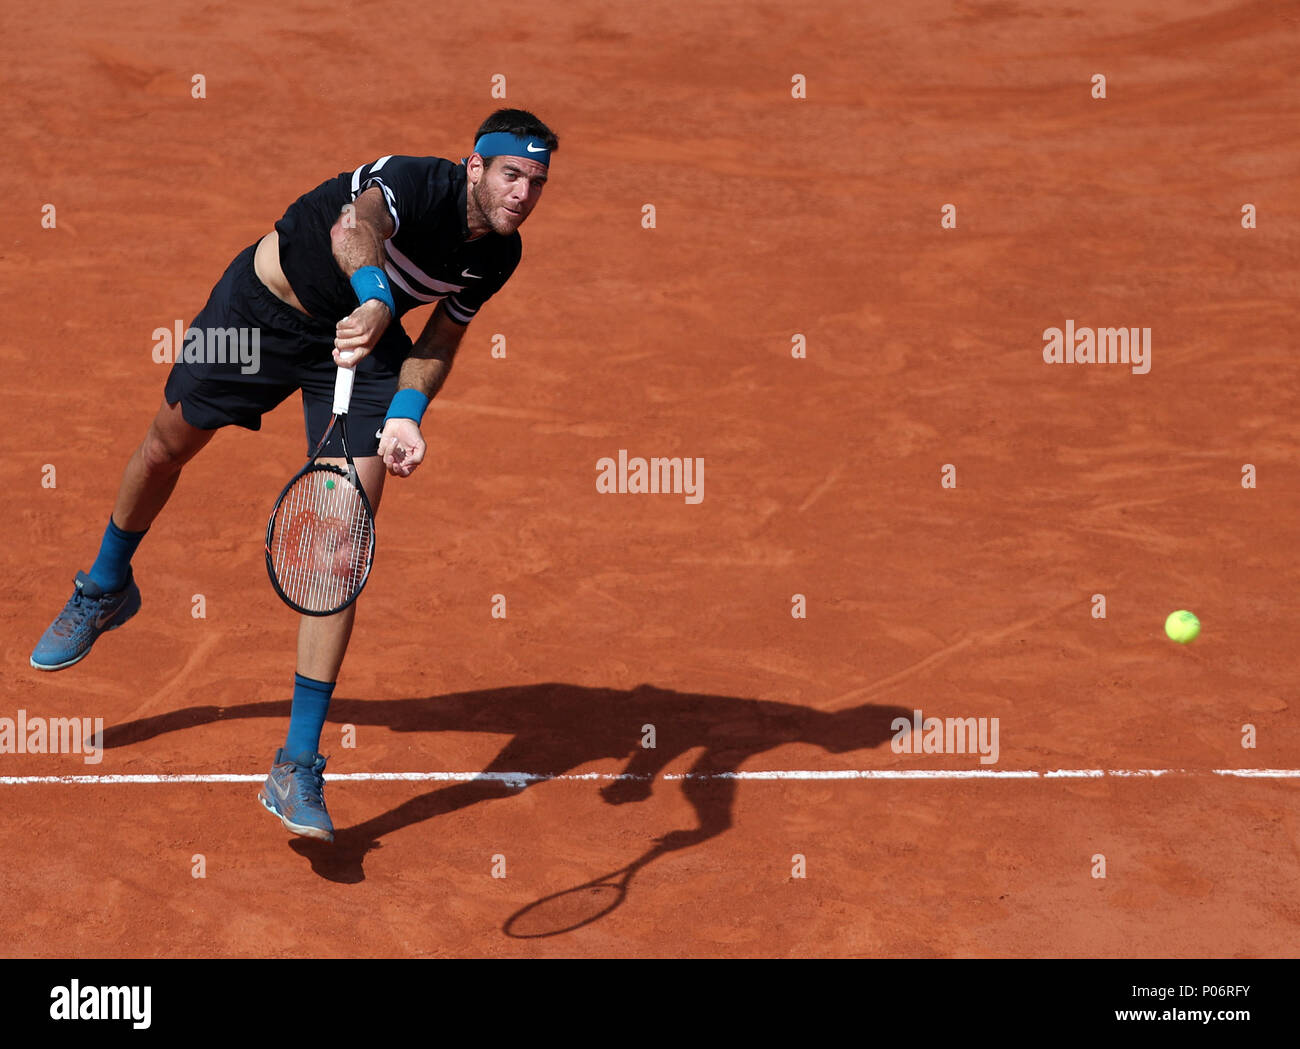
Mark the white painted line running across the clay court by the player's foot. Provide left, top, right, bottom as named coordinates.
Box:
left=0, top=768, right=1300, bottom=786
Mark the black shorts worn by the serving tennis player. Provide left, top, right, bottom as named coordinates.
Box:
left=164, top=244, right=411, bottom=456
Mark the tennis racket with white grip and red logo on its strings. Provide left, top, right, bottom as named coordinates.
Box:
left=267, top=354, right=374, bottom=616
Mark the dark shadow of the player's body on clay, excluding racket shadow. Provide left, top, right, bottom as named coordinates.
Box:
left=104, top=684, right=911, bottom=920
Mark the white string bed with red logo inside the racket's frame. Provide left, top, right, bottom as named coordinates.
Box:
left=270, top=471, right=374, bottom=612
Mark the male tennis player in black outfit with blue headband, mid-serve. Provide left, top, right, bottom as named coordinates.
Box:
left=31, top=109, right=558, bottom=841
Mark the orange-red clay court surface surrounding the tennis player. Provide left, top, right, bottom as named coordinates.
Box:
left=0, top=0, right=1300, bottom=957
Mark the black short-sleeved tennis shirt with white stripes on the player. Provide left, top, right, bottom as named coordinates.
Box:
left=276, top=156, right=523, bottom=324
